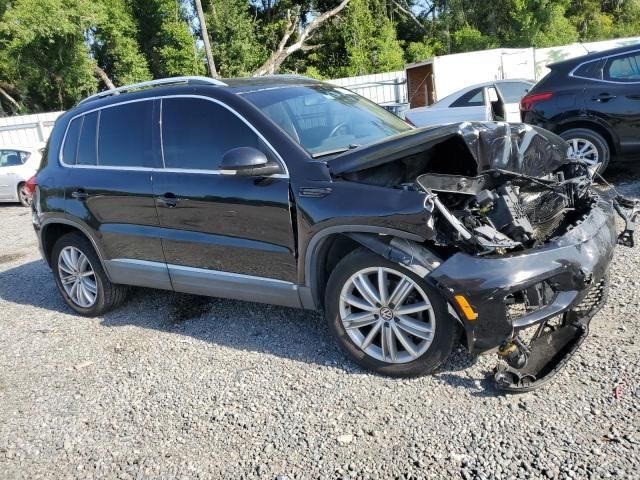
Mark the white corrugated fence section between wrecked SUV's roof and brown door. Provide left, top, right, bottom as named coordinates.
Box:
left=327, top=70, right=407, bottom=105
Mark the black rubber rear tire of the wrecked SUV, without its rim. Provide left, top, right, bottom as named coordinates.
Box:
left=51, top=232, right=128, bottom=317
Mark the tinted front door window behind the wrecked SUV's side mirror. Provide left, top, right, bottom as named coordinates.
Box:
left=162, top=98, right=270, bottom=170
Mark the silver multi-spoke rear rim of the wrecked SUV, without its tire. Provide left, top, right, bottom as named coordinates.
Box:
left=58, top=246, right=98, bottom=308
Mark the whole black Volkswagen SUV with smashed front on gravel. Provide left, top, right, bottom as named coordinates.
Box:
left=32, top=76, right=638, bottom=391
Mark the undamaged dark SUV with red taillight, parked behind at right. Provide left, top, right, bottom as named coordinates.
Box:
left=520, top=45, right=640, bottom=173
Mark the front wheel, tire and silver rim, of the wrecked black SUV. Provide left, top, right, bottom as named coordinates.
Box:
left=325, top=249, right=457, bottom=377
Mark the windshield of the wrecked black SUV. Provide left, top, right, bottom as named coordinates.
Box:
left=243, top=85, right=411, bottom=158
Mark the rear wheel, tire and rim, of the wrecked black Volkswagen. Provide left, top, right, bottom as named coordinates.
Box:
left=51, top=232, right=127, bottom=317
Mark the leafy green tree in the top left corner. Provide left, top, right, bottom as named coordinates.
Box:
left=0, top=0, right=103, bottom=110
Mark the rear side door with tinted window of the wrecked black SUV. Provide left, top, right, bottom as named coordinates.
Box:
left=62, top=100, right=170, bottom=288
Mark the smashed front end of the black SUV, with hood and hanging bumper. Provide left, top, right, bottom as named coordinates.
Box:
left=330, top=122, right=640, bottom=391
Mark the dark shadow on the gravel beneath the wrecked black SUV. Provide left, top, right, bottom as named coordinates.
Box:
left=0, top=261, right=496, bottom=396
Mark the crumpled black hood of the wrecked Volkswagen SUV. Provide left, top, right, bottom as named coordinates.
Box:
left=327, top=122, right=570, bottom=177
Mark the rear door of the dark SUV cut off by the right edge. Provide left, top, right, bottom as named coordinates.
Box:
left=584, top=50, right=640, bottom=153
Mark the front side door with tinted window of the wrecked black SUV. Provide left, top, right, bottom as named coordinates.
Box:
left=153, top=97, right=296, bottom=304
